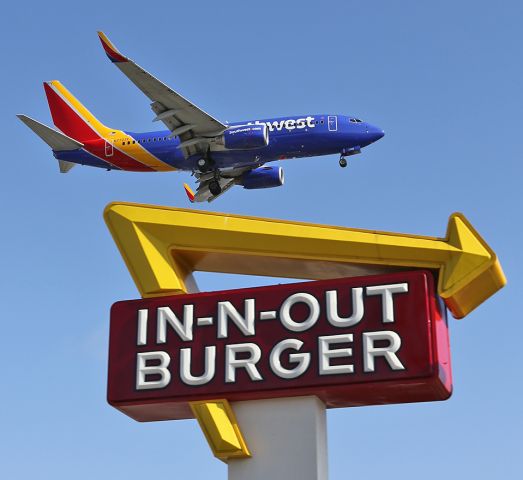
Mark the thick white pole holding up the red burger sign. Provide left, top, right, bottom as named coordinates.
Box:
left=228, top=396, right=328, bottom=480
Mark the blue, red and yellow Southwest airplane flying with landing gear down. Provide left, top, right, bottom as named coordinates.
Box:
left=17, top=32, right=384, bottom=202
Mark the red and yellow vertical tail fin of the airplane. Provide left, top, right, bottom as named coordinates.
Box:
left=44, top=80, right=111, bottom=142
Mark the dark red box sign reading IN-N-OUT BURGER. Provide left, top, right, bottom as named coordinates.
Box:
left=108, top=271, right=451, bottom=421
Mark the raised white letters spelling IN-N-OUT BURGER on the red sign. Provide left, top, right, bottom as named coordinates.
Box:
left=136, top=282, right=409, bottom=390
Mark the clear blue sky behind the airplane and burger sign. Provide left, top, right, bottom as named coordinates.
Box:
left=0, top=0, right=523, bottom=480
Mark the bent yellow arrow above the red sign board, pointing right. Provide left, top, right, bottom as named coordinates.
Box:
left=105, top=203, right=506, bottom=318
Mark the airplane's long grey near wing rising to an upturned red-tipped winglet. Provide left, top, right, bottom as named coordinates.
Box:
left=98, top=32, right=227, bottom=158
